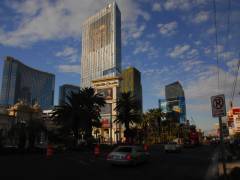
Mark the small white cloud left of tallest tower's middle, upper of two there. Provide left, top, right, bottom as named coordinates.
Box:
left=55, top=46, right=80, bottom=63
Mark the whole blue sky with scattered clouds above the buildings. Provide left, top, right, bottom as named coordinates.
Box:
left=0, top=0, right=240, bottom=130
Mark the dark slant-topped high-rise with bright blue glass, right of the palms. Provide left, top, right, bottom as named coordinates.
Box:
left=165, top=81, right=186, bottom=123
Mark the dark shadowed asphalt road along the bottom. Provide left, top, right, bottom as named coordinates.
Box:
left=0, top=146, right=214, bottom=180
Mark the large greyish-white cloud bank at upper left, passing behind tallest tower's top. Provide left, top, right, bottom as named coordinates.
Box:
left=0, top=0, right=150, bottom=47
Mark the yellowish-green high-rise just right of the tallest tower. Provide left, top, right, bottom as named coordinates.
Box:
left=120, top=67, right=142, bottom=111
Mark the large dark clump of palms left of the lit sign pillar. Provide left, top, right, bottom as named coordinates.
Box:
left=52, top=87, right=105, bottom=145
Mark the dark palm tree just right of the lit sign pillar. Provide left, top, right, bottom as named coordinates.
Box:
left=114, top=92, right=141, bottom=142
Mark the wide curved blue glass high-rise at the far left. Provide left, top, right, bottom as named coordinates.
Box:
left=0, top=56, right=55, bottom=109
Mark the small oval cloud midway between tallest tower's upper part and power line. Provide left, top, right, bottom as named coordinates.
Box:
left=157, top=21, right=178, bottom=36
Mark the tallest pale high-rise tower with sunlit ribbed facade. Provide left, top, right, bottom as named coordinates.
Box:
left=81, top=2, right=121, bottom=87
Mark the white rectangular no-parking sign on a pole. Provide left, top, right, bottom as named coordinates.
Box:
left=211, top=94, right=226, bottom=117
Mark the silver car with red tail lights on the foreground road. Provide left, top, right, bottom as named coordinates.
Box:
left=107, top=146, right=149, bottom=165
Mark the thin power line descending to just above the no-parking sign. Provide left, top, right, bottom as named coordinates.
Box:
left=213, top=0, right=220, bottom=91
